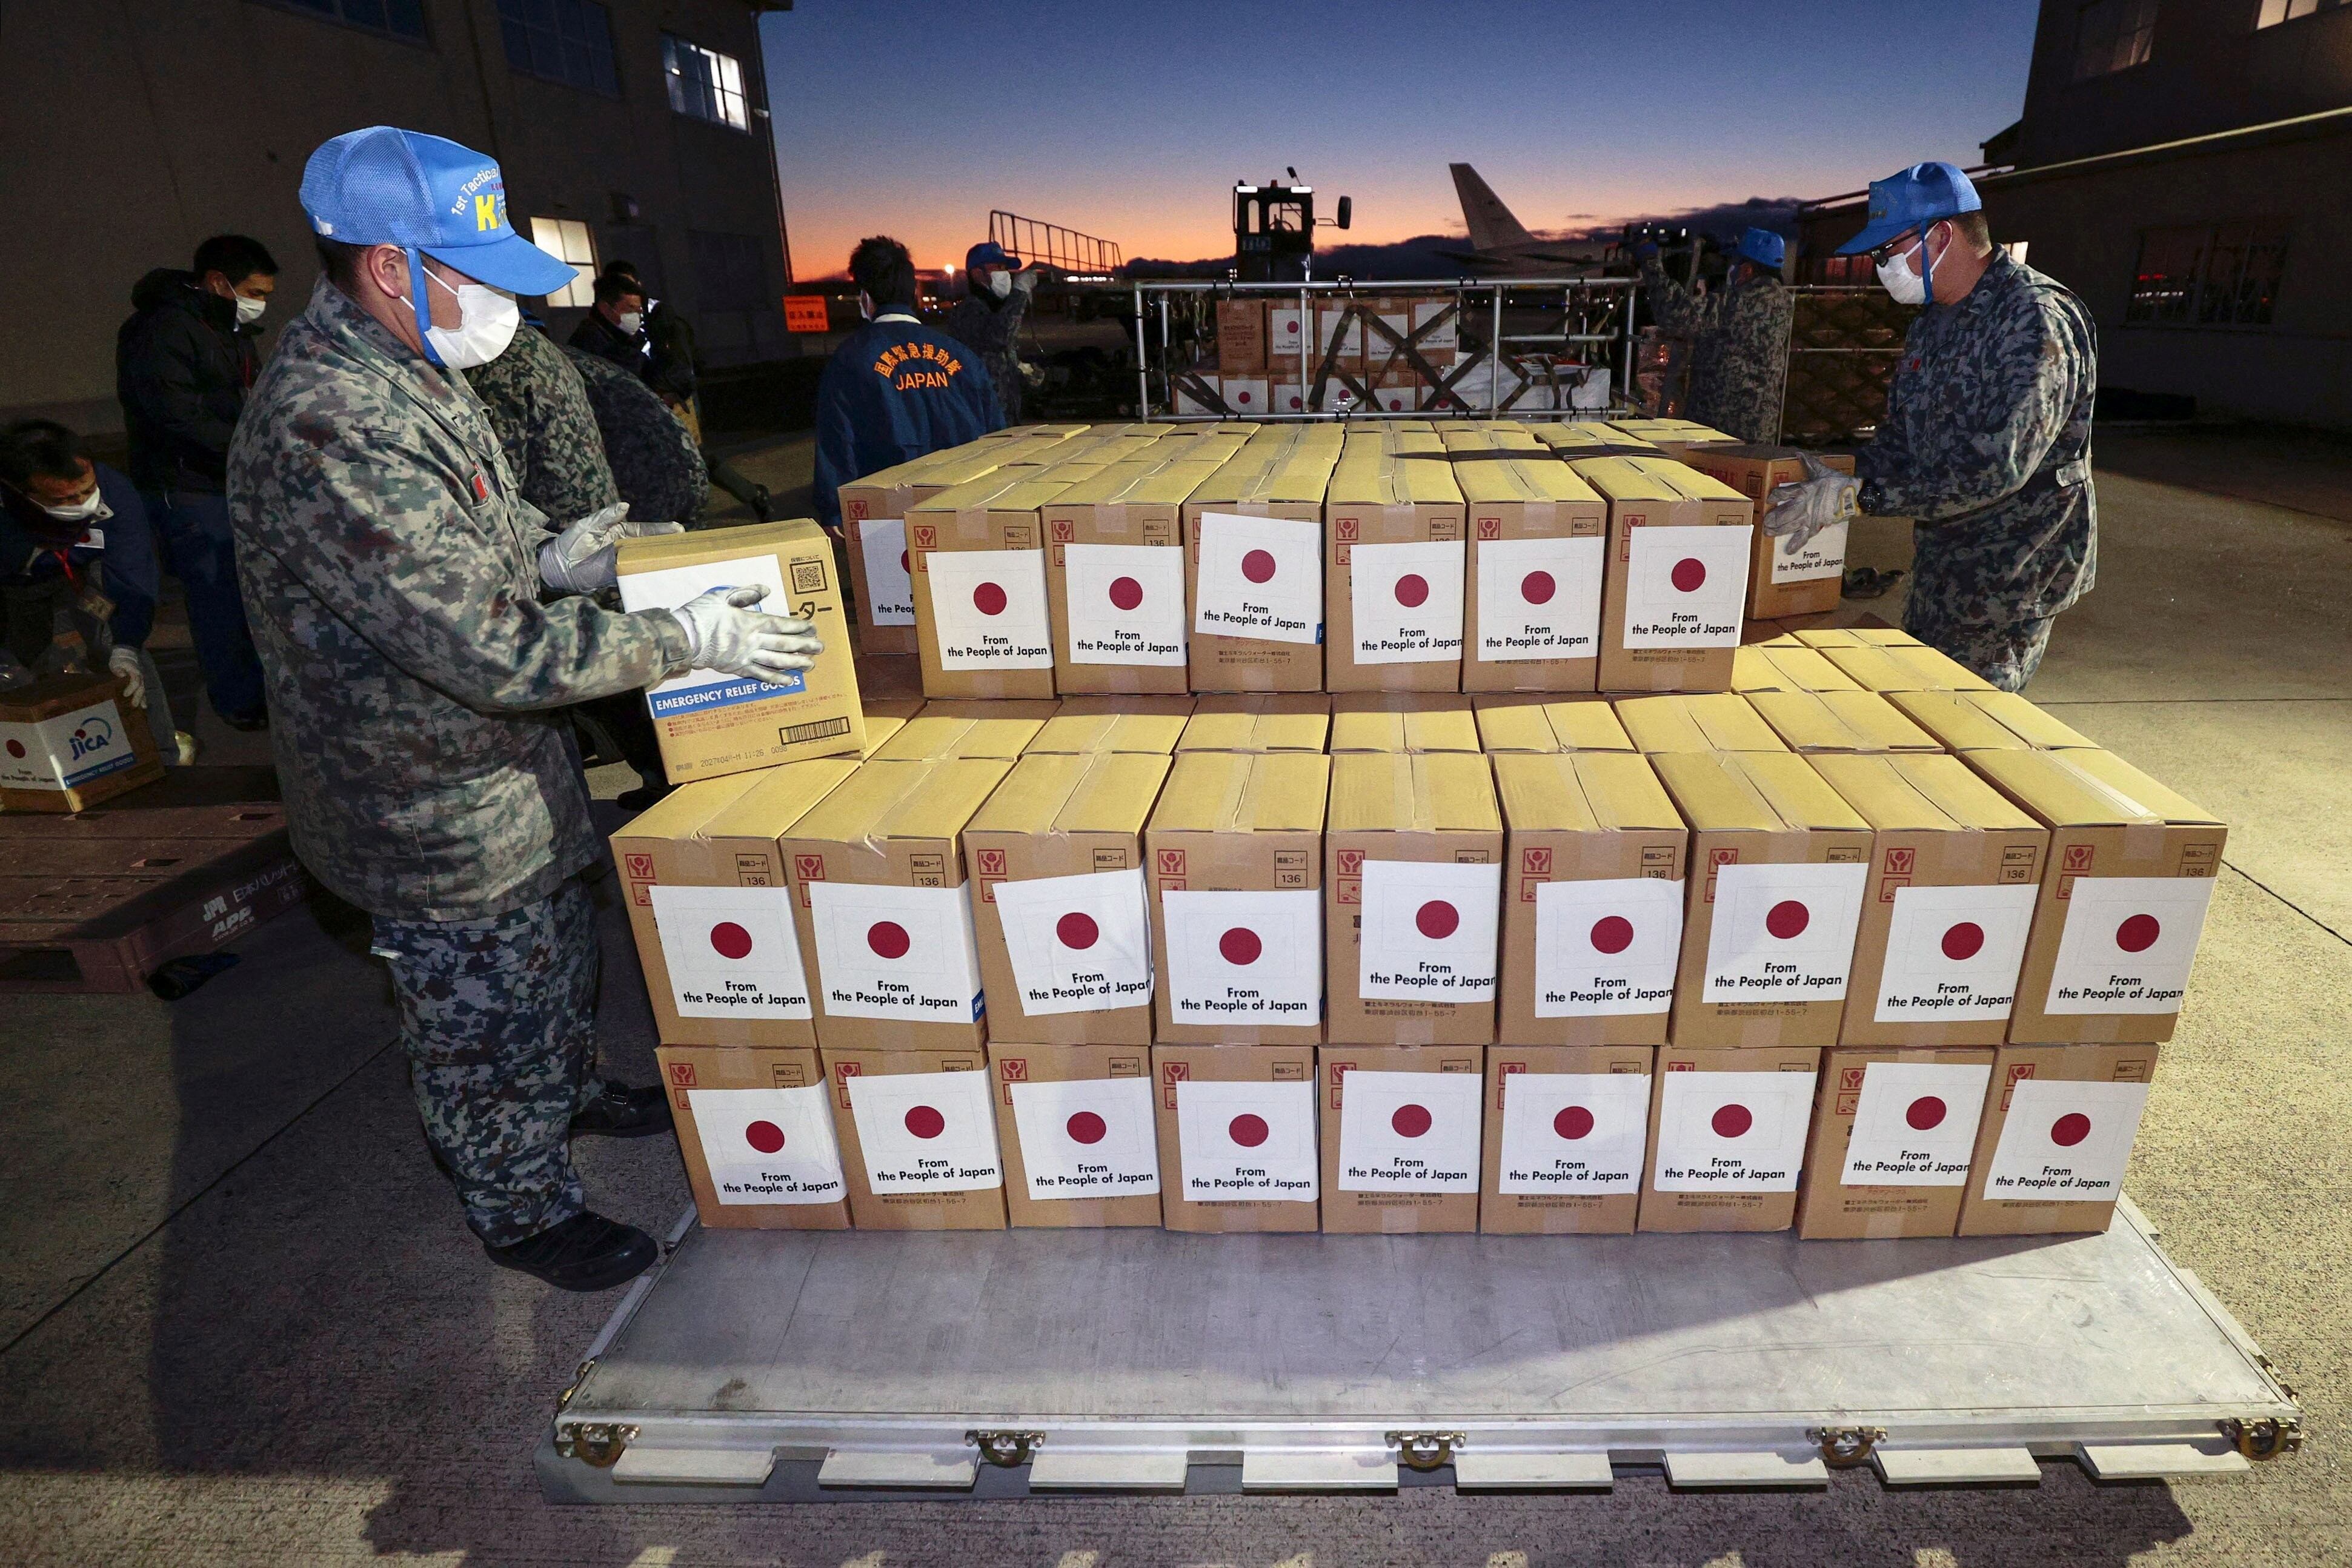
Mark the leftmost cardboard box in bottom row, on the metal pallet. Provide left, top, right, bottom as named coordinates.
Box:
left=654, top=1046, right=849, bottom=1229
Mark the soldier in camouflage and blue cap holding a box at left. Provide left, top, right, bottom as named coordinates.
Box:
left=228, top=127, right=814, bottom=1291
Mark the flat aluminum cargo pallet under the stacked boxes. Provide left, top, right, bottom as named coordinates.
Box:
left=539, top=1201, right=2301, bottom=1502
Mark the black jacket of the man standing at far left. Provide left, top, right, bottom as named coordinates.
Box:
left=115, top=268, right=261, bottom=496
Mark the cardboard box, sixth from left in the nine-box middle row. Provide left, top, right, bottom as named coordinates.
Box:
left=1493, top=752, right=1691, bottom=1046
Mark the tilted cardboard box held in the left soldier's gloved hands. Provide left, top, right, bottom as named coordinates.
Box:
left=619, top=519, right=866, bottom=783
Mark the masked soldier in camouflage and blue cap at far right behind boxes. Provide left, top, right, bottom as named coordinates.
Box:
left=1764, top=165, right=2098, bottom=691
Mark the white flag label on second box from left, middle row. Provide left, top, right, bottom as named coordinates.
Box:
left=802, top=882, right=981, bottom=1023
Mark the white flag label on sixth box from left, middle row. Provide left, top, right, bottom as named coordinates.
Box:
left=1536, top=877, right=1682, bottom=1018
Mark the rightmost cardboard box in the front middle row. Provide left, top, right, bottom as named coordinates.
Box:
left=1962, top=750, right=2230, bottom=1044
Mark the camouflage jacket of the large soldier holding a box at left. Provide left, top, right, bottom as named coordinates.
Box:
left=228, top=277, right=687, bottom=919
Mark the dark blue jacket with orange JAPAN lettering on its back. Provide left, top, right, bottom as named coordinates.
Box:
left=816, top=310, right=1005, bottom=529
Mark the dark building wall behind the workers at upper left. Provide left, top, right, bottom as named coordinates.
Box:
left=0, top=0, right=792, bottom=430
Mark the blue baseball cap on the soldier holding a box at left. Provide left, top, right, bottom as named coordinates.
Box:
left=301, top=125, right=579, bottom=294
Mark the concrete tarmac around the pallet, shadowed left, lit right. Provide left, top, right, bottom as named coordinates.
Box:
left=0, top=437, right=2352, bottom=1568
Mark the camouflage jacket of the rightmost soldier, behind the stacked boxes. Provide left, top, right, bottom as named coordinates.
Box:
left=1856, top=254, right=2098, bottom=625
